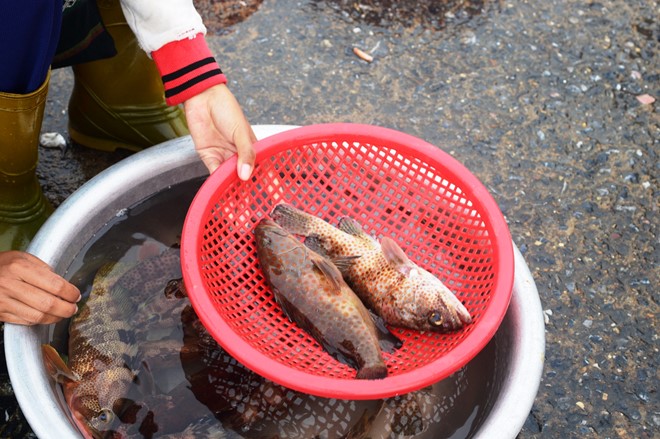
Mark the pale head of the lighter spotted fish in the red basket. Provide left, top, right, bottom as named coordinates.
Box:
left=402, top=267, right=472, bottom=332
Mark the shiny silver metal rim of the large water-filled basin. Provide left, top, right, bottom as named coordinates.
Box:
left=5, top=125, right=545, bottom=439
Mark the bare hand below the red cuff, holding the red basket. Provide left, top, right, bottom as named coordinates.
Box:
left=183, top=84, right=257, bottom=180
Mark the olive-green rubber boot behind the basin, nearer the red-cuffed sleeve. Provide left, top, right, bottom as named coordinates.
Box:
left=69, top=0, right=188, bottom=151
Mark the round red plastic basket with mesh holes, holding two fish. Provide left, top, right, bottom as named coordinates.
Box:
left=181, top=124, right=514, bottom=399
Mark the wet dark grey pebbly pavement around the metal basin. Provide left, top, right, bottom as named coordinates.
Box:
left=0, top=0, right=660, bottom=438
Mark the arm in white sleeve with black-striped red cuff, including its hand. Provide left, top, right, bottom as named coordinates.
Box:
left=122, top=0, right=256, bottom=175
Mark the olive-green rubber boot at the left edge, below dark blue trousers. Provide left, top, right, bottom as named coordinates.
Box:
left=0, top=74, right=53, bottom=251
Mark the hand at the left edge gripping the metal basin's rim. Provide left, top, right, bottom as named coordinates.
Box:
left=0, top=251, right=80, bottom=325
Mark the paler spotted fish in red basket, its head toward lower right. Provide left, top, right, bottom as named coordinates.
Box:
left=271, top=203, right=472, bottom=332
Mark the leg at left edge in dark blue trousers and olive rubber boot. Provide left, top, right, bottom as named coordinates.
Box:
left=0, top=0, right=62, bottom=251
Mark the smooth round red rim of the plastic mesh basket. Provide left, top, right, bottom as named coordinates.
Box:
left=181, top=123, right=514, bottom=399
